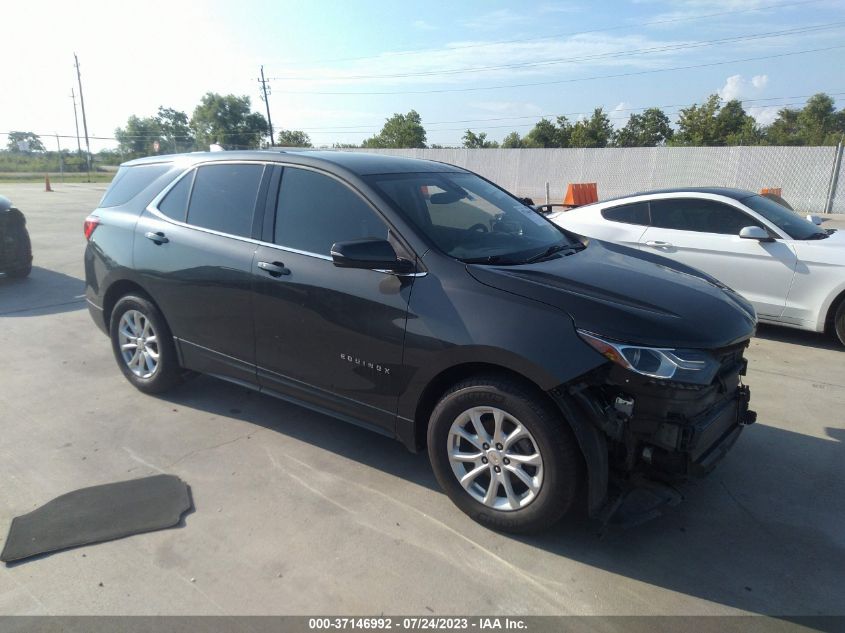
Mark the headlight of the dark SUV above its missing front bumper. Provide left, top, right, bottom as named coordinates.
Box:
left=578, top=330, right=719, bottom=385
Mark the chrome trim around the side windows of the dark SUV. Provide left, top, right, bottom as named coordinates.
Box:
left=146, top=160, right=427, bottom=277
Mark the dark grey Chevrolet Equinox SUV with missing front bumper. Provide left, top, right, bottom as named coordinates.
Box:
left=85, top=151, right=756, bottom=532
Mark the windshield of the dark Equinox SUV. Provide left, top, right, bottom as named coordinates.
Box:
left=367, top=173, right=583, bottom=264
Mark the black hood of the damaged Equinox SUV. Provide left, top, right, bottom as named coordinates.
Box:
left=467, top=240, right=757, bottom=349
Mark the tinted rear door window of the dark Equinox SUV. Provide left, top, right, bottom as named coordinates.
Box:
left=187, top=164, right=264, bottom=237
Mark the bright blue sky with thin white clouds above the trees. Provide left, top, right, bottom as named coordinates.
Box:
left=0, top=0, right=845, bottom=151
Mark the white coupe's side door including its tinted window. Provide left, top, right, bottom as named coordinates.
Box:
left=640, top=198, right=796, bottom=317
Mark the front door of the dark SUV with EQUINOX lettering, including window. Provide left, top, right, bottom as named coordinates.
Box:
left=253, top=167, right=414, bottom=433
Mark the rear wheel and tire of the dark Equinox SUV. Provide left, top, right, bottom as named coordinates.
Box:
left=109, top=295, right=182, bottom=393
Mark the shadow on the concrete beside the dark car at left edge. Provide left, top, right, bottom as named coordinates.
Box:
left=0, top=266, right=85, bottom=317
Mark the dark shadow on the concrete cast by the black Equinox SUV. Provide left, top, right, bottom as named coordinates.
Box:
left=160, top=377, right=845, bottom=615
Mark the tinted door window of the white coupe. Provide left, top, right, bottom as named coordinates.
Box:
left=651, top=198, right=760, bottom=235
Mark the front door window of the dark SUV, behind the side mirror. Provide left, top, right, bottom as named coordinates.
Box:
left=273, top=167, right=387, bottom=255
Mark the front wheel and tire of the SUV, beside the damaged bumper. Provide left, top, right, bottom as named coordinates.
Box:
left=428, top=376, right=582, bottom=533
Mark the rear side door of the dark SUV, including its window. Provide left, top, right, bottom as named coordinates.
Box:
left=135, top=162, right=269, bottom=382
